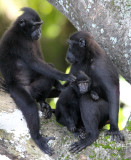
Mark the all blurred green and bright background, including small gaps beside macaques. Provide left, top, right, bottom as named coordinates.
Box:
left=0, top=0, right=131, bottom=129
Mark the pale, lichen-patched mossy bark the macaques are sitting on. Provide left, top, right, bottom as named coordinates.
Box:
left=0, top=91, right=131, bottom=160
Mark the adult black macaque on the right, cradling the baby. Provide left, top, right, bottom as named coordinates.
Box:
left=58, top=31, right=124, bottom=152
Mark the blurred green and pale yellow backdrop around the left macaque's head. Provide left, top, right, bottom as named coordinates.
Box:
left=0, top=0, right=75, bottom=72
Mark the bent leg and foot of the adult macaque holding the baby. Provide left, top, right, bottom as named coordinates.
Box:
left=70, top=90, right=109, bottom=153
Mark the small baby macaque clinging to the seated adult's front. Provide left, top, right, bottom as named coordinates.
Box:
left=55, top=71, right=99, bottom=136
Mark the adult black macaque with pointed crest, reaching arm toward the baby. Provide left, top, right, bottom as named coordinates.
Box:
left=0, top=8, right=75, bottom=155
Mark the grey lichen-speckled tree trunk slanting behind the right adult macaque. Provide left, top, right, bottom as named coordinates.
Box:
left=48, top=0, right=131, bottom=83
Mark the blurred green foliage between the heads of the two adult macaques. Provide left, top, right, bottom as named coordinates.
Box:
left=27, top=0, right=75, bottom=72
